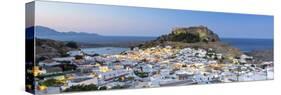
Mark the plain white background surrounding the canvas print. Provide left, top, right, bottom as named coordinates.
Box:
left=0, top=0, right=281, bottom=95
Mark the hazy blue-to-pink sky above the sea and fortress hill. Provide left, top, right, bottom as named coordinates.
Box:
left=31, top=1, right=273, bottom=38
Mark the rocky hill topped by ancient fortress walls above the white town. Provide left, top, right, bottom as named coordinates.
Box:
left=138, top=26, right=242, bottom=56
